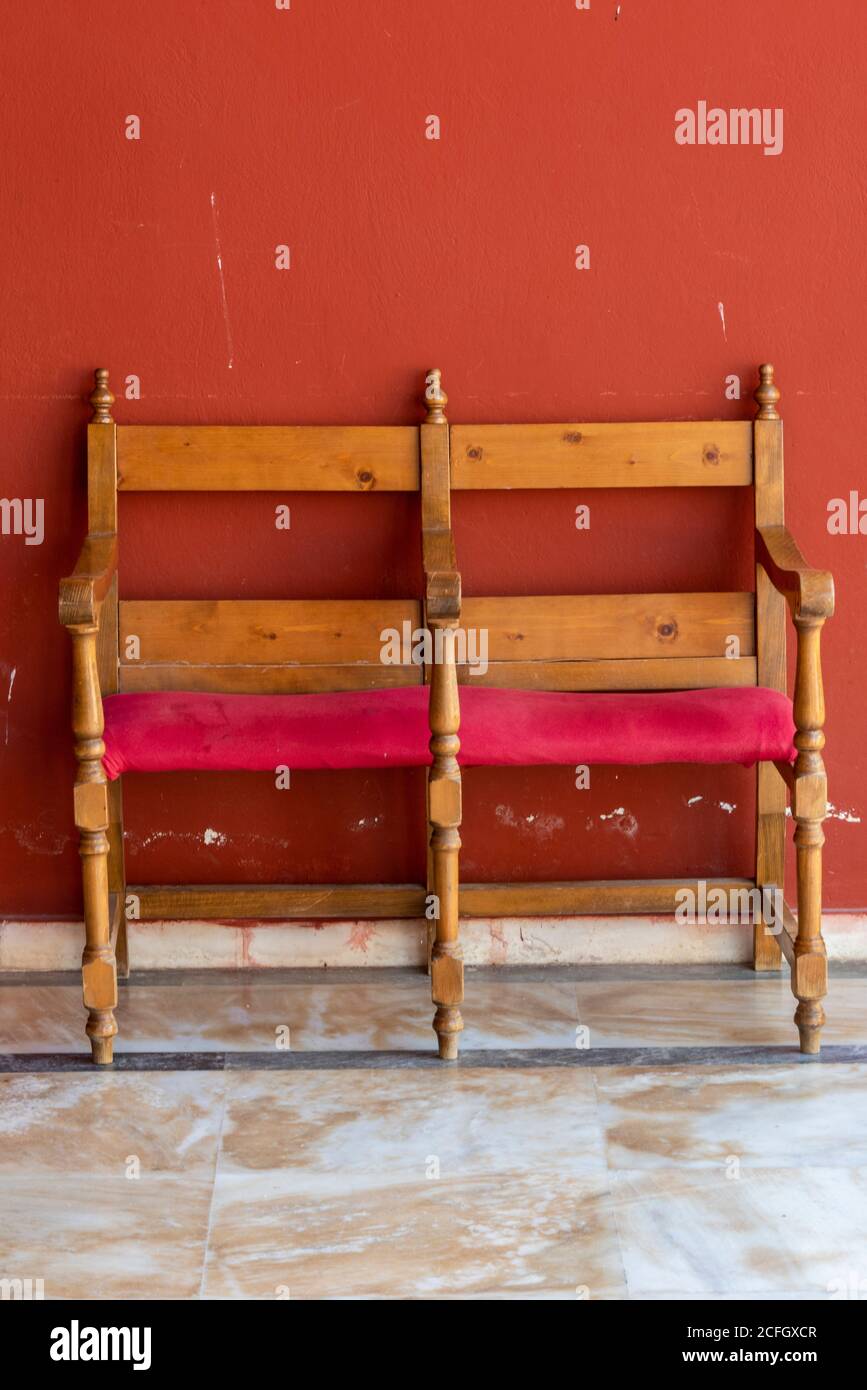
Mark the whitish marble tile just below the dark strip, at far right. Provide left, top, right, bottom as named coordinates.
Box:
left=593, top=1062, right=867, bottom=1172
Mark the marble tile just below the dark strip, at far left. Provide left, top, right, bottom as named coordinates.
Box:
left=0, top=1072, right=226, bottom=1183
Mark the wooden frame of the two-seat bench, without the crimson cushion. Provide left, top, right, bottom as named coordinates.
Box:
left=60, top=364, right=834, bottom=1065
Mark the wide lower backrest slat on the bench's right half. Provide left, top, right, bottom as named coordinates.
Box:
left=461, top=594, right=756, bottom=662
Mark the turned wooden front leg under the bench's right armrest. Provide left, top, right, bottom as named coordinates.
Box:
left=792, top=617, right=828, bottom=1055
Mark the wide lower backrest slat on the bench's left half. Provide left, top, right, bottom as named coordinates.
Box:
left=119, top=599, right=421, bottom=667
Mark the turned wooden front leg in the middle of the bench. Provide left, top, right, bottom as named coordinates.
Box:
left=429, top=630, right=464, bottom=1062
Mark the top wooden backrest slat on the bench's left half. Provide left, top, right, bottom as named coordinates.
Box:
left=117, top=425, right=420, bottom=492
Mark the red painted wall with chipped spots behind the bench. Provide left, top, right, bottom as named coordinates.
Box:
left=0, top=0, right=867, bottom=915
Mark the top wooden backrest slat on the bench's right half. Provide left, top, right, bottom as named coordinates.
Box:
left=452, top=420, right=753, bottom=488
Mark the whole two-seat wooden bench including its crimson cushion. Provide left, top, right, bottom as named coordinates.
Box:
left=60, top=366, right=834, bottom=1065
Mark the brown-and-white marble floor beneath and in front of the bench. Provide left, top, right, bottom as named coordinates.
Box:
left=0, top=966, right=867, bottom=1300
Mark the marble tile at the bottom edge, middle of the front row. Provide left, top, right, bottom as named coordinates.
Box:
left=204, top=1172, right=625, bottom=1300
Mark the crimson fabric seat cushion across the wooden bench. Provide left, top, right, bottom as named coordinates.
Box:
left=97, top=684, right=795, bottom=778
